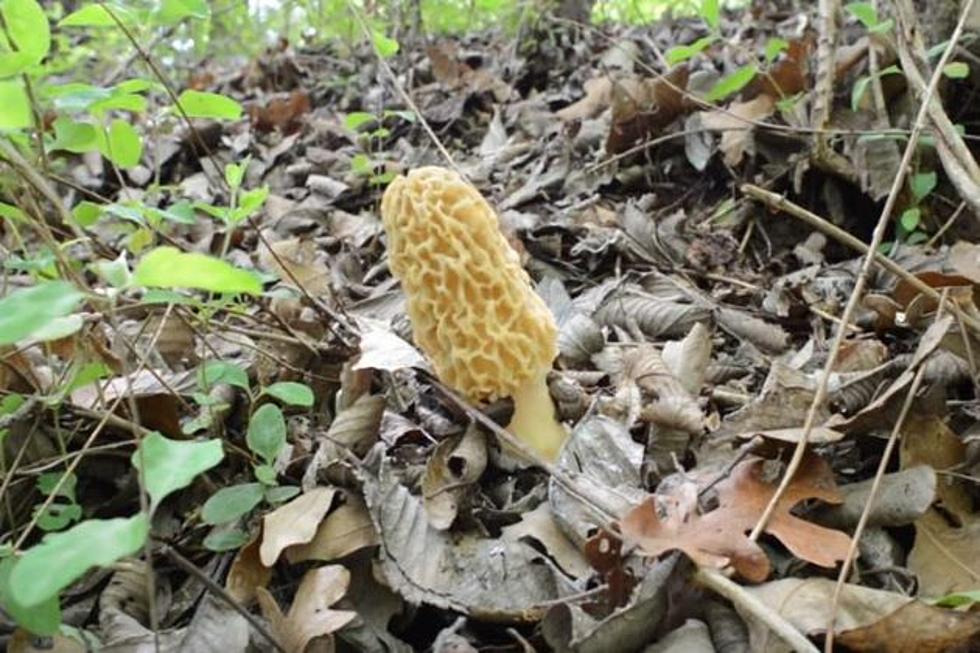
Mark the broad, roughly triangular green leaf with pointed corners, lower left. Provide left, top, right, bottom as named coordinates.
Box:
left=130, top=432, right=225, bottom=510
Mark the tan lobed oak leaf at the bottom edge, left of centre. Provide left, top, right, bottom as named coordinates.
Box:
left=258, top=565, right=357, bottom=653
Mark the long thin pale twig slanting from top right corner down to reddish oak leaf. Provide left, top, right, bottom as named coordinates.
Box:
left=749, top=0, right=973, bottom=542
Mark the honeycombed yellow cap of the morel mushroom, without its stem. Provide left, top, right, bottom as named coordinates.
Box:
left=381, top=166, right=558, bottom=401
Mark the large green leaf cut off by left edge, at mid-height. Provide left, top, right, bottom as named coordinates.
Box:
left=0, top=281, right=82, bottom=345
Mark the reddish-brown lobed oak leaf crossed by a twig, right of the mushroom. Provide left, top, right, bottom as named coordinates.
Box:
left=620, top=454, right=850, bottom=582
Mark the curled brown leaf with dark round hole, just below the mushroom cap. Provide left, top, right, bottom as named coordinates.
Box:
left=422, top=425, right=487, bottom=530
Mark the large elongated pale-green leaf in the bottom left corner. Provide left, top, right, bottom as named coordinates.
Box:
left=10, top=513, right=150, bottom=608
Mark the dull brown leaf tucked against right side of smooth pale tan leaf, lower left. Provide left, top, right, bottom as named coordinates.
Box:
left=285, top=494, right=378, bottom=564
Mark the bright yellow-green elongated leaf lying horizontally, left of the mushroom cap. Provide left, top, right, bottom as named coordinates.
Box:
left=133, top=247, right=262, bottom=295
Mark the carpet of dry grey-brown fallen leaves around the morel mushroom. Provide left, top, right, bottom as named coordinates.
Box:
left=9, top=8, right=980, bottom=653
